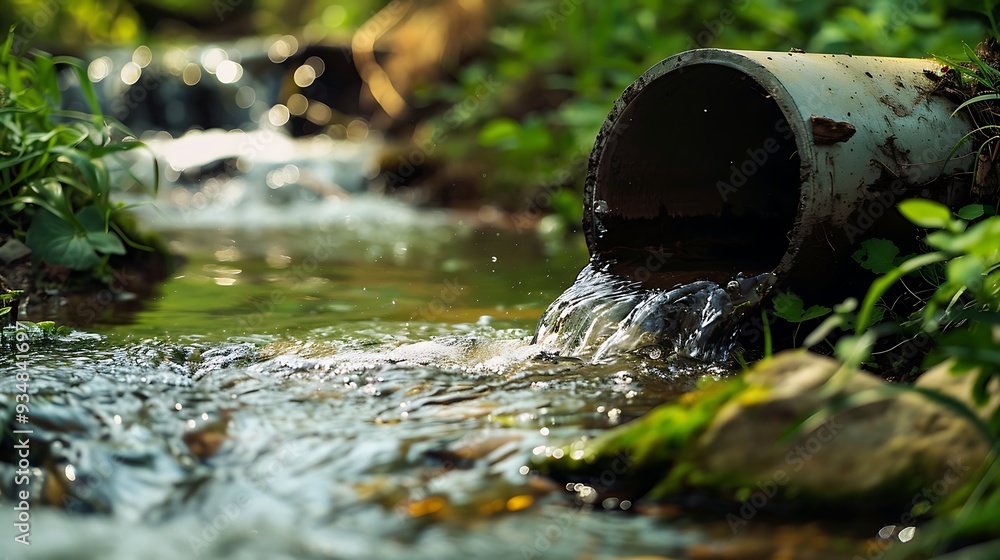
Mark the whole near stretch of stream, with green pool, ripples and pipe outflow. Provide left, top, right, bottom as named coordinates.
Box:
left=0, top=135, right=868, bottom=560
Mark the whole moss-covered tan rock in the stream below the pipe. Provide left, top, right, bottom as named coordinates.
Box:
left=539, top=351, right=989, bottom=513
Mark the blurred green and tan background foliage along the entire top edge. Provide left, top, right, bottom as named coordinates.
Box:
left=0, top=0, right=989, bottom=223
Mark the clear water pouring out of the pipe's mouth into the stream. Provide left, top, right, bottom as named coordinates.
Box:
left=533, top=262, right=774, bottom=362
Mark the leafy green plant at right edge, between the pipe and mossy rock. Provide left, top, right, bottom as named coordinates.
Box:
left=804, top=199, right=1000, bottom=370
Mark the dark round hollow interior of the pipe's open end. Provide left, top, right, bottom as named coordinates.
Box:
left=588, top=64, right=800, bottom=287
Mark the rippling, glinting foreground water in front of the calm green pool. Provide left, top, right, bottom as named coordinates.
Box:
left=0, top=325, right=720, bottom=558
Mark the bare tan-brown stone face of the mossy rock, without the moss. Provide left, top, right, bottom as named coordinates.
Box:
left=695, top=352, right=989, bottom=498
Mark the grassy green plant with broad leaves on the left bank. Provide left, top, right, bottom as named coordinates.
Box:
left=0, top=29, right=155, bottom=270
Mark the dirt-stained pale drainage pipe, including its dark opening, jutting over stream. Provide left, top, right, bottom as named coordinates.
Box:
left=584, top=49, right=972, bottom=300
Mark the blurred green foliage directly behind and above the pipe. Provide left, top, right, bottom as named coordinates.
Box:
left=418, top=0, right=987, bottom=217
